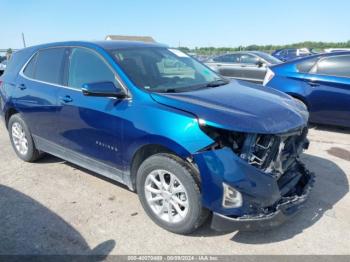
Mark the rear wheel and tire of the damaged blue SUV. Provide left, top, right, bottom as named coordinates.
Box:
left=8, top=114, right=41, bottom=162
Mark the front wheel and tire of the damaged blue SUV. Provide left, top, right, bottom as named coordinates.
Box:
left=136, top=154, right=209, bottom=234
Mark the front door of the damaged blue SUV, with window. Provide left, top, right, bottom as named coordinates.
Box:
left=58, top=47, right=129, bottom=169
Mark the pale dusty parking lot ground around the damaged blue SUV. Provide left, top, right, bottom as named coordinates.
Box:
left=0, top=125, right=350, bottom=255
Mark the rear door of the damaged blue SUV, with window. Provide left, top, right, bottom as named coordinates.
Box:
left=14, top=47, right=66, bottom=142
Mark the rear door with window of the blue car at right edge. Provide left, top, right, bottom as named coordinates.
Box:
left=305, top=55, right=350, bottom=126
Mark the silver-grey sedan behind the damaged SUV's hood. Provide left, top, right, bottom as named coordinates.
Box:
left=205, top=51, right=282, bottom=84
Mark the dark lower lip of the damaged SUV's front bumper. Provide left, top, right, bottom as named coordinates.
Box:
left=211, top=166, right=314, bottom=231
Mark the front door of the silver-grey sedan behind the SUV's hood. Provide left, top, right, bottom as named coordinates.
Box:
left=240, top=54, right=266, bottom=83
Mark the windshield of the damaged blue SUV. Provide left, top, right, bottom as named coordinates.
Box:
left=111, top=47, right=227, bottom=92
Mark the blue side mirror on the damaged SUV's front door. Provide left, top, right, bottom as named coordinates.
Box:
left=82, top=82, right=126, bottom=98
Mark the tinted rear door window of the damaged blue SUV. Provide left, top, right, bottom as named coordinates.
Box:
left=32, top=48, right=65, bottom=84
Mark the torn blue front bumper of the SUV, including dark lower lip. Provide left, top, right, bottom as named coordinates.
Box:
left=194, top=145, right=314, bottom=231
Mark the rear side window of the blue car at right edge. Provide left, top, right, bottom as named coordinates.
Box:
left=313, top=55, right=350, bottom=77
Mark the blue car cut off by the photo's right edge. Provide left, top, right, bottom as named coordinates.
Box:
left=263, top=52, right=350, bottom=127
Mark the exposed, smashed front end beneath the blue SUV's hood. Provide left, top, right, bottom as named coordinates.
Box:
left=202, top=124, right=309, bottom=179
